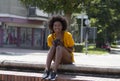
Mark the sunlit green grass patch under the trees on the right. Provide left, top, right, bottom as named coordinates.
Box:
left=83, top=45, right=108, bottom=55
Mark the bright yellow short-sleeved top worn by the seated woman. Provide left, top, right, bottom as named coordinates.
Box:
left=47, top=31, right=74, bottom=62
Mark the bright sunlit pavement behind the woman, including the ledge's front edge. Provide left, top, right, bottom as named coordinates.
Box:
left=0, top=48, right=120, bottom=74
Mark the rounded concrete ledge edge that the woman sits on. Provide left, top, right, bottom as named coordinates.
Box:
left=0, top=60, right=120, bottom=74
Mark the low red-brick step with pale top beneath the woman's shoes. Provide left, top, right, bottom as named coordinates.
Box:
left=0, top=70, right=92, bottom=81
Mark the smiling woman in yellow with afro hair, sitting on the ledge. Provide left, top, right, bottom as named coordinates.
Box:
left=43, top=16, right=74, bottom=80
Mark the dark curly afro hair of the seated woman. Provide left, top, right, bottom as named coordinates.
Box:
left=48, top=15, right=67, bottom=33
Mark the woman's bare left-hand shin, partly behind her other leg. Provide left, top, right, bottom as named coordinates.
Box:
left=45, top=46, right=56, bottom=70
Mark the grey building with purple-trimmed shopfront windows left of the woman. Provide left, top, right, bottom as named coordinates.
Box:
left=0, top=0, right=48, bottom=49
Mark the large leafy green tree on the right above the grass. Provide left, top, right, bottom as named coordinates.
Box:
left=85, top=0, right=120, bottom=42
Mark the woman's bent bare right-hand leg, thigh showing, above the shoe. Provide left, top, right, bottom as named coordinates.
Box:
left=53, top=46, right=72, bottom=72
